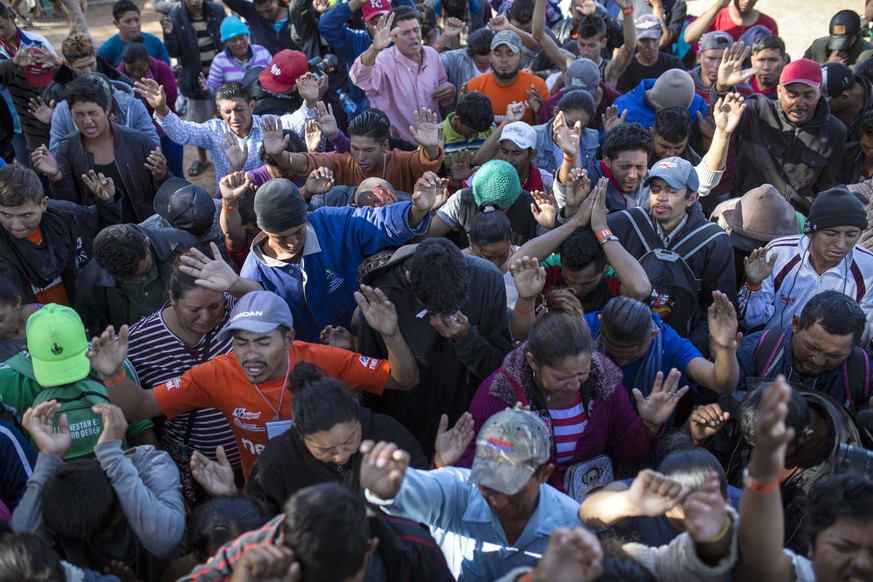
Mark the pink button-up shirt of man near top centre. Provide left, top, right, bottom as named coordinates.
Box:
left=349, top=46, right=448, bottom=143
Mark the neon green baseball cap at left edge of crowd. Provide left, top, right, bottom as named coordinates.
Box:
left=27, top=303, right=91, bottom=386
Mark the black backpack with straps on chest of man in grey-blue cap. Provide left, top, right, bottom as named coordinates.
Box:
left=621, top=208, right=727, bottom=337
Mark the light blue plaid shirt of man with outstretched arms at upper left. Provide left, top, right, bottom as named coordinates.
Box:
left=154, top=103, right=315, bottom=192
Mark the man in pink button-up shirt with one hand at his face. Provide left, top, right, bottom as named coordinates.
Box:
left=349, top=6, right=455, bottom=145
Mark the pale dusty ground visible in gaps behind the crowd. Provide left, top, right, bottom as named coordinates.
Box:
left=25, top=0, right=852, bottom=192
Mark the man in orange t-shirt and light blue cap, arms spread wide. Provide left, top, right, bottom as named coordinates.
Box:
left=88, top=290, right=418, bottom=479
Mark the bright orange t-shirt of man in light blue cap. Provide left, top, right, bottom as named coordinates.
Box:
left=154, top=341, right=391, bottom=479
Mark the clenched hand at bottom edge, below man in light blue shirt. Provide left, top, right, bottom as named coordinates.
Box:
left=530, top=527, right=603, bottom=582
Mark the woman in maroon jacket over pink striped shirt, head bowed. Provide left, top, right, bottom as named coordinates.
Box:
left=458, top=289, right=688, bottom=490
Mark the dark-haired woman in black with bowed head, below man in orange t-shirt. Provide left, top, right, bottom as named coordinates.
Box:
left=191, top=362, right=473, bottom=515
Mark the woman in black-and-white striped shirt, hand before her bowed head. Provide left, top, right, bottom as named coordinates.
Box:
left=127, top=243, right=261, bottom=503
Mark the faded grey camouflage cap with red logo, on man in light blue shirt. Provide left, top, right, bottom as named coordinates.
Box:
left=470, top=409, right=551, bottom=495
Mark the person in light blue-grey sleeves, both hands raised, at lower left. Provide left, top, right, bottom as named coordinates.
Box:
left=12, top=400, right=185, bottom=580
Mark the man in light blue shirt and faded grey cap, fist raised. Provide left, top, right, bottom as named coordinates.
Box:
left=360, top=409, right=581, bottom=582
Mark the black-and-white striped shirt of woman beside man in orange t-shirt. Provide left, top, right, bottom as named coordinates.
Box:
left=127, top=293, right=240, bottom=470
